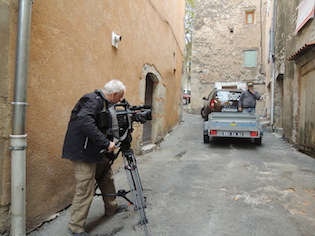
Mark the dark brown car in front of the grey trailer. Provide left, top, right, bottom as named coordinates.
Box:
left=200, top=88, right=243, bottom=121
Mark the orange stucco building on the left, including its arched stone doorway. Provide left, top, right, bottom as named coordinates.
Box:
left=0, top=0, right=185, bottom=235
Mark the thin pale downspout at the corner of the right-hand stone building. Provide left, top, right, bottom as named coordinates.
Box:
left=270, top=0, right=277, bottom=130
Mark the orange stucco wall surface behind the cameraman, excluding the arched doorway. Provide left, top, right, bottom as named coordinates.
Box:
left=0, top=0, right=185, bottom=230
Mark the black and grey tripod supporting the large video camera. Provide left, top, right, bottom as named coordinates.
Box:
left=95, top=147, right=149, bottom=236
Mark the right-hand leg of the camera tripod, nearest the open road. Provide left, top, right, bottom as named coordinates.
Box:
left=123, top=150, right=149, bottom=236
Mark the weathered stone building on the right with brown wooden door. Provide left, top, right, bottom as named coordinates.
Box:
left=268, top=0, right=315, bottom=154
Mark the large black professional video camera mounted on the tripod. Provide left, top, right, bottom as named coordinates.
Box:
left=98, top=99, right=152, bottom=141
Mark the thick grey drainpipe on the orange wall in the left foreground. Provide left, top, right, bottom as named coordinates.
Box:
left=10, top=0, right=33, bottom=236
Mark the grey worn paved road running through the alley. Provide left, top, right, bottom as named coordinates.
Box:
left=29, top=114, right=315, bottom=236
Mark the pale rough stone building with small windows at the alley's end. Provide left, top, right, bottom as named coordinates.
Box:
left=190, top=0, right=266, bottom=115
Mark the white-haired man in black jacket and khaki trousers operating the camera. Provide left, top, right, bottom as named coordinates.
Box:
left=62, top=80, right=128, bottom=236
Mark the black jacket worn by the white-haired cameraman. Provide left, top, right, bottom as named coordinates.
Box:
left=62, top=90, right=111, bottom=163
